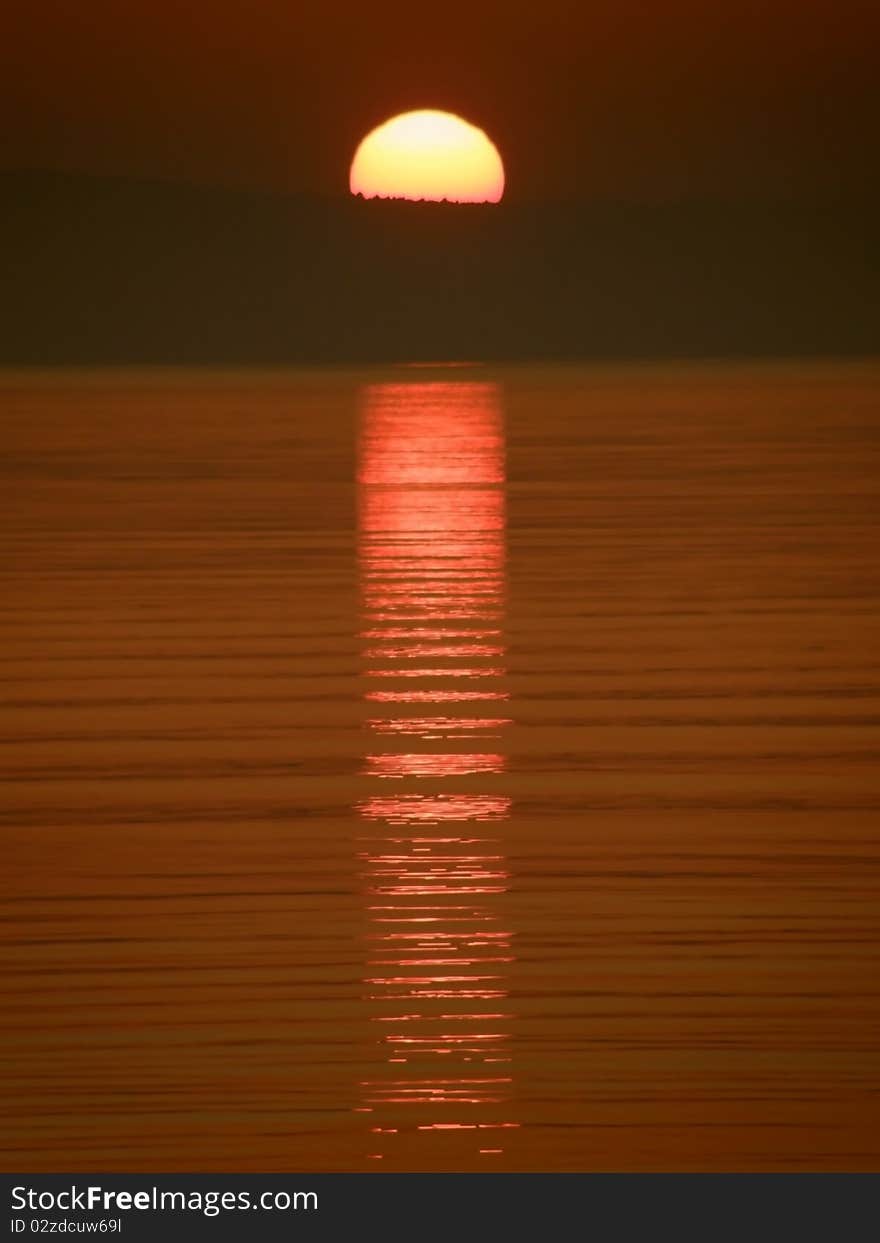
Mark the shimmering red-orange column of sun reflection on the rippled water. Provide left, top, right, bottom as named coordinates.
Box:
left=357, top=382, right=518, bottom=1168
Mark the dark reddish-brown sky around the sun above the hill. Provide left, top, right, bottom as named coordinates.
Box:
left=0, top=0, right=880, bottom=199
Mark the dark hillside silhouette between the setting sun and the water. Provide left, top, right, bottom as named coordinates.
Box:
left=0, top=174, right=880, bottom=364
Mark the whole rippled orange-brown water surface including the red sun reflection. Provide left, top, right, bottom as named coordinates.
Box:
left=0, top=364, right=880, bottom=1171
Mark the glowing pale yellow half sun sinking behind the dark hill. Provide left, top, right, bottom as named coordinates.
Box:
left=349, top=108, right=505, bottom=203
